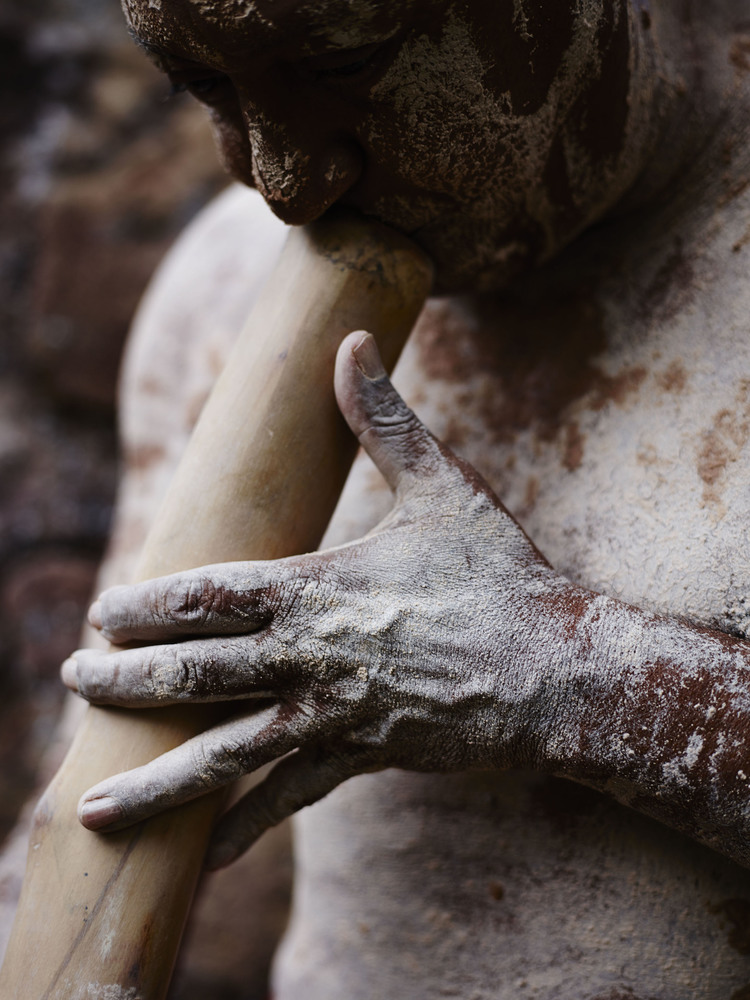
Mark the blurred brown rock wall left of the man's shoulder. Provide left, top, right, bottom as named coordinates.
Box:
left=0, top=0, right=225, bottom=842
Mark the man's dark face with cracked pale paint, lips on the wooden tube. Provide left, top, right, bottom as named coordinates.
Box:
left=124, top=0, right=630, bottom=291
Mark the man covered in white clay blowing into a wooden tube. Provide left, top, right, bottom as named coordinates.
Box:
left=64, top=0, right=750, bottom=1000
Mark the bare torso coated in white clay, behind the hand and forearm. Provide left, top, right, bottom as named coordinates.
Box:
left=117, top=184, right=750, bottom=1000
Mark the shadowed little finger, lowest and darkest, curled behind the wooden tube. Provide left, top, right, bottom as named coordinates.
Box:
left=205, top=744, right=379, bottom=871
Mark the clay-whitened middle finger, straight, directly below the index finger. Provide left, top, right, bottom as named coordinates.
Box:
left=62, top=635, right=284, bottom=708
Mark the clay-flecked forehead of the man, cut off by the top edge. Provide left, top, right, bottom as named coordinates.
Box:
left=122, top=0, right=412, bottom=61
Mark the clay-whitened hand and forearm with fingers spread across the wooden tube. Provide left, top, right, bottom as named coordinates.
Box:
left=63, top=333, right=750, bottom=866
